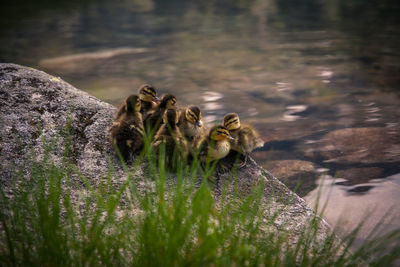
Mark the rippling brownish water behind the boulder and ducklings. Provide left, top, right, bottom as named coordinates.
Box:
left=0, top=0, right=400, bottom=247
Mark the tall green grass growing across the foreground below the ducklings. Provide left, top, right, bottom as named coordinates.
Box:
left=0, top=130, right=400, bottom=266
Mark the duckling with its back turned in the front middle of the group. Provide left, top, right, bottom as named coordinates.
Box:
left=153, top=109, right=188, bottom=170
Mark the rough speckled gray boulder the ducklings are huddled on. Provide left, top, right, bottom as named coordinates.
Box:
left=0, top=64, right=336, bottom=247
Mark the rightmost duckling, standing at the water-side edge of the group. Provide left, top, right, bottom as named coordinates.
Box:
left=222, top=113, right=264, bottom=167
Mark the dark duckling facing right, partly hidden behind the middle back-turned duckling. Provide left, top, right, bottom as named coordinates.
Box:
left=143, top=94, right=176, bottom=133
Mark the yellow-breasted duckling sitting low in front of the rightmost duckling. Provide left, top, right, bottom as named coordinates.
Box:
left=199, top=125, right=233, bottom=163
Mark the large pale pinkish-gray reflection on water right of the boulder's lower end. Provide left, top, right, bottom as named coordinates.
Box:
left=305, top=173, right=400, bottom=249
